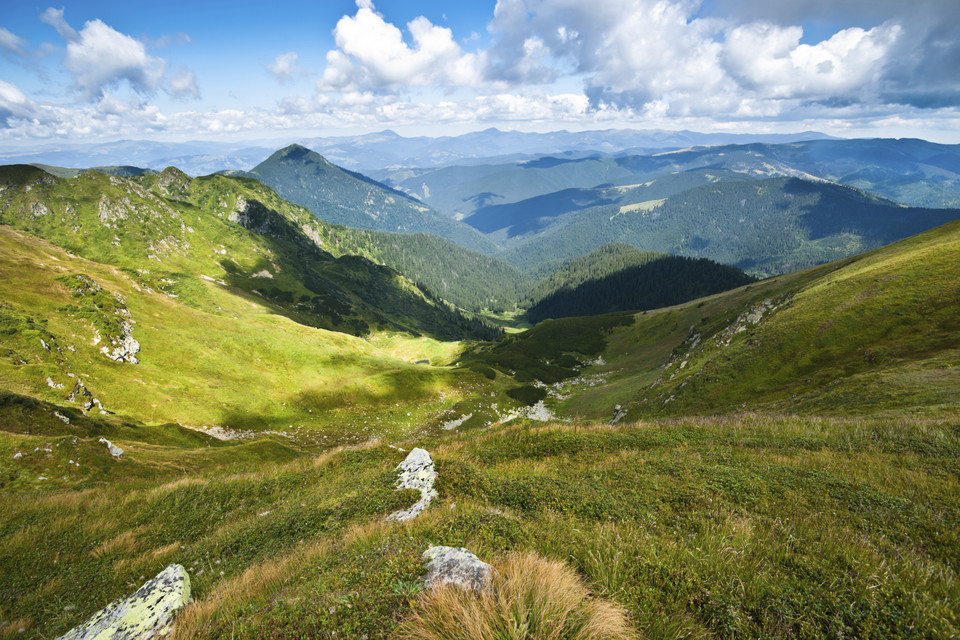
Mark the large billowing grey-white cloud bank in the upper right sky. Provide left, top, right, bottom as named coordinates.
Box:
left=483, top=0, right=936, bottom=117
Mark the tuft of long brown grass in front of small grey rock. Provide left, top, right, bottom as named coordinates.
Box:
left=397, top=553, right=637, bottom=640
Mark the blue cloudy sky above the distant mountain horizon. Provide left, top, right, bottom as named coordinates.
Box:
left=0, top=0, right=960, bottom=147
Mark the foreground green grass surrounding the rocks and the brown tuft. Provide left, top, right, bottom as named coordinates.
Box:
left=0, top=416, right=960, bottom=638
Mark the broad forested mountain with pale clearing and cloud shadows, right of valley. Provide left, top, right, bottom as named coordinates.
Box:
left=503, top=178, right=960, bottom=276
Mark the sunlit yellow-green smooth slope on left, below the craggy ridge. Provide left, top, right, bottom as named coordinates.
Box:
left=0, top=227, right=492, bottom=441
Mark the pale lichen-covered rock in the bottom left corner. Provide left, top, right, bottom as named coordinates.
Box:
left=57, top=564, right=190, bottom=640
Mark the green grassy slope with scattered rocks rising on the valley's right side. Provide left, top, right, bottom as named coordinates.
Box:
left=488, top=222, right=960, bottom=418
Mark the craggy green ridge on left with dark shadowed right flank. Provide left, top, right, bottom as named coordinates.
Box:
left=0, top=166, right=489, bottom=338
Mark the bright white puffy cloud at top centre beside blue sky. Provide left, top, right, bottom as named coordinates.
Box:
left=317, top=0, right=481, bottom=91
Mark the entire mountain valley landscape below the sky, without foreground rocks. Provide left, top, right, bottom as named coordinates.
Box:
left=0, top=132, right=960, bottom=640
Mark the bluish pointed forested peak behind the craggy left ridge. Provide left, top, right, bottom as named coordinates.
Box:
left=245, top=145, right=493, bottom=254
